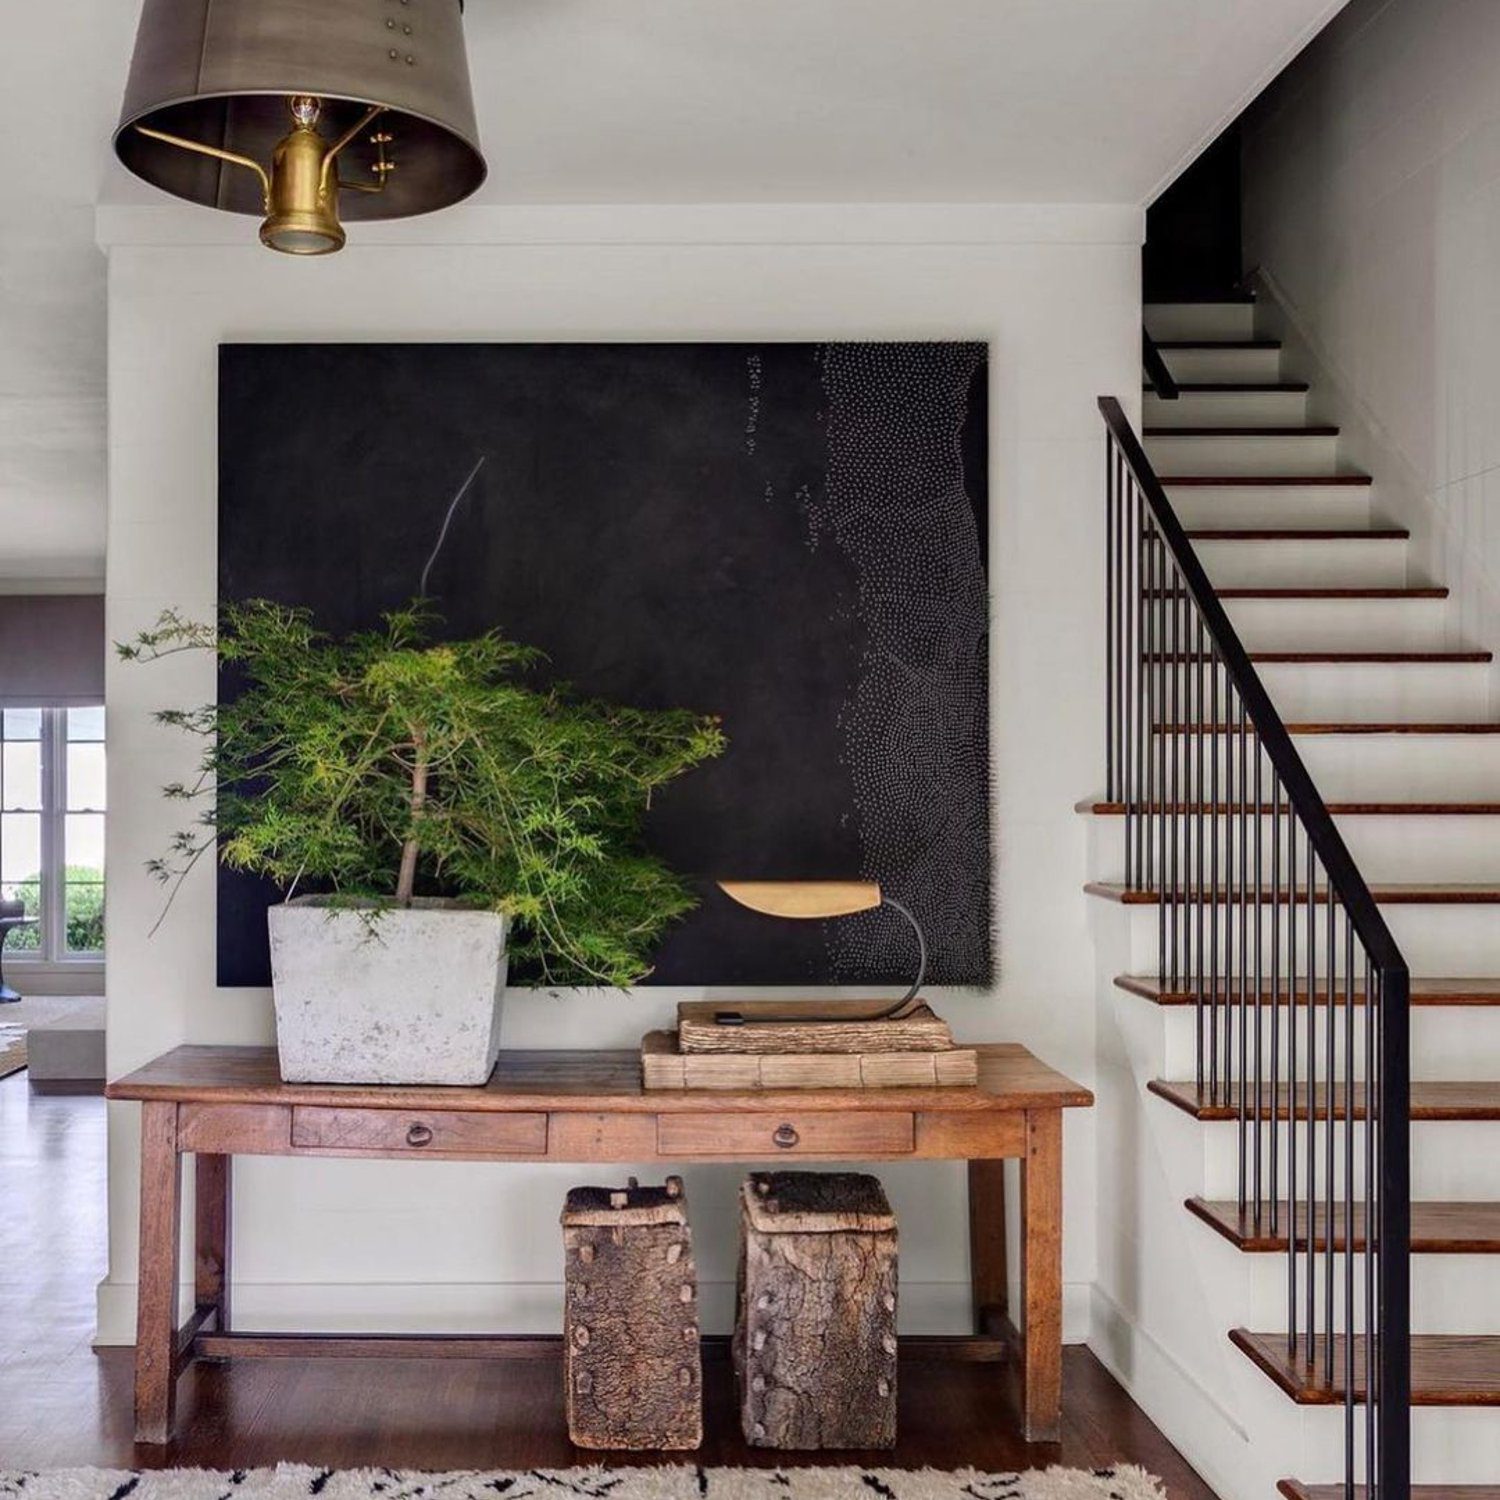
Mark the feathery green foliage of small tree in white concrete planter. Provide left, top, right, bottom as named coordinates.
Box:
left=119, top=600, right=725, bottom=986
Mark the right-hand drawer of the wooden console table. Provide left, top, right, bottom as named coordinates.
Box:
left=657, top=1110, right=917, bottom=1157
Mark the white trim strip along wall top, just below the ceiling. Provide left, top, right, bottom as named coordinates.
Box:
left=95, top=198, right=1146, bottom=255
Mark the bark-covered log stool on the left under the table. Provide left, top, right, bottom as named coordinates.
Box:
left=563, top=1178, right=704, bottom=1448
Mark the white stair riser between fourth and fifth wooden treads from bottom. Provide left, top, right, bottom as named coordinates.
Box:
left=1142, top=1002, right=1500, bottom=1086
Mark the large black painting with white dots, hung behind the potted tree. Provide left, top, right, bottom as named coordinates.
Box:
left=219, top=344, right=992, bottom=986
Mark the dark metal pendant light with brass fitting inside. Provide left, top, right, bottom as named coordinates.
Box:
left=114, top=0, right=486, bottom=255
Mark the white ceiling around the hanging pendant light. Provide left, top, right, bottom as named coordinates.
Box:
left=0, top=0, right=1341, bottom=588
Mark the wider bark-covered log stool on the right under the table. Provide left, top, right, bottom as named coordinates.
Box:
left=734, top=1172, right=896, bottom=1448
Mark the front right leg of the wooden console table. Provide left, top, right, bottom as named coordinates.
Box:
left=1022, top=1110, right=1062, bottom=1443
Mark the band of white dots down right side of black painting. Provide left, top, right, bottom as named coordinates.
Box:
left=809, top=344, right=993, bottom=984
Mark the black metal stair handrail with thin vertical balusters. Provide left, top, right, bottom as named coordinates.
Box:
left=1100, top=396, right=1410, bottom=1500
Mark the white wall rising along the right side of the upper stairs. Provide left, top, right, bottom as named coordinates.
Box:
left=1244, top=0, right=1500, bottom=660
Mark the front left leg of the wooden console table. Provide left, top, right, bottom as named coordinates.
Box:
left=135, top=1103, right=182, bottom=1443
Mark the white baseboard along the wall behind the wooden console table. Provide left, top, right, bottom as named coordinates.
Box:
left=95, top=1280, right=1091, bottom=1347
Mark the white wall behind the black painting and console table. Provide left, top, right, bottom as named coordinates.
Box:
left=101, top=206, right=1142, bottom=1343
